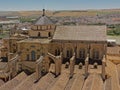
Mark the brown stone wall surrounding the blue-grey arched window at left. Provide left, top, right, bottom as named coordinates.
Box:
left=18, top=42, right=48, bottom=61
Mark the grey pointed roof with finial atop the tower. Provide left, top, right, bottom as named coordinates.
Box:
left=35, top=9, right=53, bottom=25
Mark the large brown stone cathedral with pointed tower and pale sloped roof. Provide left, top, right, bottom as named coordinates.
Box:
left=1, top=10, right=107, bottom=67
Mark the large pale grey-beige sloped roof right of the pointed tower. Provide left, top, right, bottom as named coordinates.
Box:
left=53, top=25, right=107, bottom=41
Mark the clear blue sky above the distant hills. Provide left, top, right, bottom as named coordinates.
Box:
left=0, top=0, right=120, bottom=11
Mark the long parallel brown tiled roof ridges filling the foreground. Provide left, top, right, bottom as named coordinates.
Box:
left=0, top=60, right=120, bottom=90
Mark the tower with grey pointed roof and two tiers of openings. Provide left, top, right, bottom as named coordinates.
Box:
left=29, top=9, right=56, bottom=38
